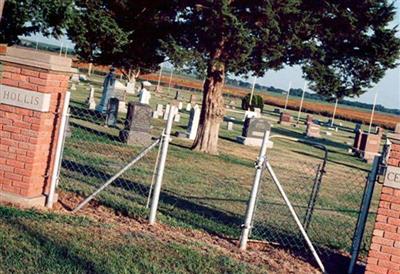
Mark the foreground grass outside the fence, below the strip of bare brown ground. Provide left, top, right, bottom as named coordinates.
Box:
left=0, top=206, right=267, bottom=274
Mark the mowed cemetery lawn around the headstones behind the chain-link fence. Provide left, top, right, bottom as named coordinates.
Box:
left=61, top=75, right=382, bottom=264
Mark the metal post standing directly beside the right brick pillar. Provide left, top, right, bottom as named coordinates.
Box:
left=347, top=156, right=381, bottom=274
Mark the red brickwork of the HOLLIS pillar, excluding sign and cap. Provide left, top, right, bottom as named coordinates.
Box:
left=0, top=47, right=69, bottom=203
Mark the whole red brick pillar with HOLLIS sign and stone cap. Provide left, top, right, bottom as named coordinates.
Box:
left=0, top=45, right=72, bottom=206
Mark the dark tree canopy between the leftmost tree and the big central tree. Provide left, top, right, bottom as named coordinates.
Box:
left=68, top=0, right=173, bottom=75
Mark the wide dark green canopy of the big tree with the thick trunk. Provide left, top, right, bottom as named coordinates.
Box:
left=168, top=0, right=400, bottom=98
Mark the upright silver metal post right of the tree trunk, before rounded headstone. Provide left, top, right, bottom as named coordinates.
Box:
left=240, top=124, right=271, bottom=250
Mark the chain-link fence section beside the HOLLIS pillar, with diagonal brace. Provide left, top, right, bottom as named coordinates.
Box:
left=60, top=81, right=160, bottom=217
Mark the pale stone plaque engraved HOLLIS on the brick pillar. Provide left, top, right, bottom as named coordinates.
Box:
left=0, top=85, right=51, bottom=112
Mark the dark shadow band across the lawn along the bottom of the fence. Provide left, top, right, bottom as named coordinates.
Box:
left=63, top=158, right=366, bottom=273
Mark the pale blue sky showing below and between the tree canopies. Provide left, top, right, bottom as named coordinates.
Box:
left=25, top=0, right=400, bottom=109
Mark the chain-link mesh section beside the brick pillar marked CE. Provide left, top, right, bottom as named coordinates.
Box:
left=248, top=138, right=376, bottom=260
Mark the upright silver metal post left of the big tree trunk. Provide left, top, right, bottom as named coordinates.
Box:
left=149, top=105, right=177, bottom=225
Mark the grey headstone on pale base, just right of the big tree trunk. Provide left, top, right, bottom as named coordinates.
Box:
left=236, top=117, right=273, bottom=148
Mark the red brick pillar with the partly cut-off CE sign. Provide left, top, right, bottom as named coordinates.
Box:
left=365, top=134, right=400, bottom=274
